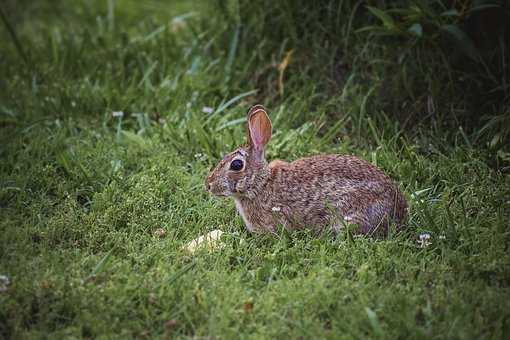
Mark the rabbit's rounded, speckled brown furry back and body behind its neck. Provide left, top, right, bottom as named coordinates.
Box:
left=263, top=155, right=407, bottom=233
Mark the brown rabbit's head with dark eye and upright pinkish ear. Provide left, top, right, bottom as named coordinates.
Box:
left=205, top=105, right=272, bottom=197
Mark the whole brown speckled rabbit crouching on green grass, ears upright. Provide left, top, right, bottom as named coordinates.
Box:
left=205, top=105, right=408, bottom=235
